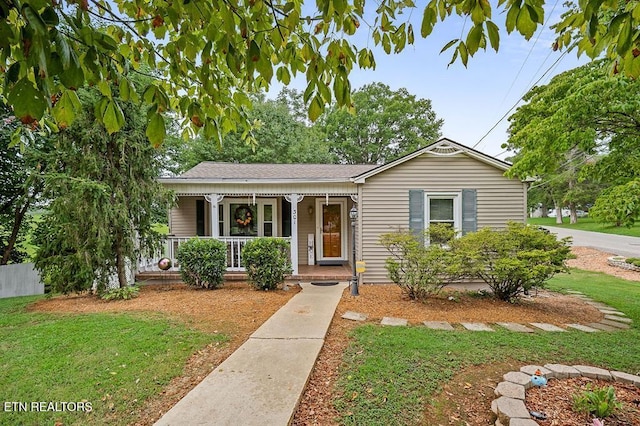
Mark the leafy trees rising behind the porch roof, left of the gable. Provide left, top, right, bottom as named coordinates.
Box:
left=174, top=91, right=332, bottom=171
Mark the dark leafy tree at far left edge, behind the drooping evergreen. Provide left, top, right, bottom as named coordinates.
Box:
left=0, top=104, right=52, bottom=265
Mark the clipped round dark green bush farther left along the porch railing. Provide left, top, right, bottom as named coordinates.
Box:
left=176, top=238, right=227, bottom=289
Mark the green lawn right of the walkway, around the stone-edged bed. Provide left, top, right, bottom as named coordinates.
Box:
left=335, top=270, right=640, bottom=425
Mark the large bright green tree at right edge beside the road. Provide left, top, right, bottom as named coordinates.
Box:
left=504, top=61, right=640, bottom=223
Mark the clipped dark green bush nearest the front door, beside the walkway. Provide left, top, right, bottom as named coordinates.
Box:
left=242, top=237, right=292, bottom=290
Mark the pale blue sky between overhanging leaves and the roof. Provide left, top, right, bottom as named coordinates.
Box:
left=270, top=2, right=588, bottom=159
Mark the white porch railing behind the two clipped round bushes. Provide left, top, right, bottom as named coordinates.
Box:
left=138, top=237, right=291, bottom=272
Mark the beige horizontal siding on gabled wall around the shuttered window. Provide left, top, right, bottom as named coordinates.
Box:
left=360, top=154, right=526, bottom=283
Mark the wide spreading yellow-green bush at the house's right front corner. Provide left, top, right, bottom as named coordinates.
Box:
left=452, top=223, right=570, bottom=301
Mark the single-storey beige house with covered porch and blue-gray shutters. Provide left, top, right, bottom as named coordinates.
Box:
left=161, top=139, right=527, bottom=283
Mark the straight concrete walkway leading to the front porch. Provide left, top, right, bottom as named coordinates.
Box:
left=155, top=283, right=347, bottom=426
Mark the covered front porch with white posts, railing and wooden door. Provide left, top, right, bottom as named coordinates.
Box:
left=139, top=190, right=357, bottom=274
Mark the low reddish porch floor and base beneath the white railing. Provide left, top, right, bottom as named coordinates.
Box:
left=136, top=265, right=352, bottom=283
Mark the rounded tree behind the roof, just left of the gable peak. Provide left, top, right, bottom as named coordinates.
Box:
left=324, top=83, right=443, bottom=164
